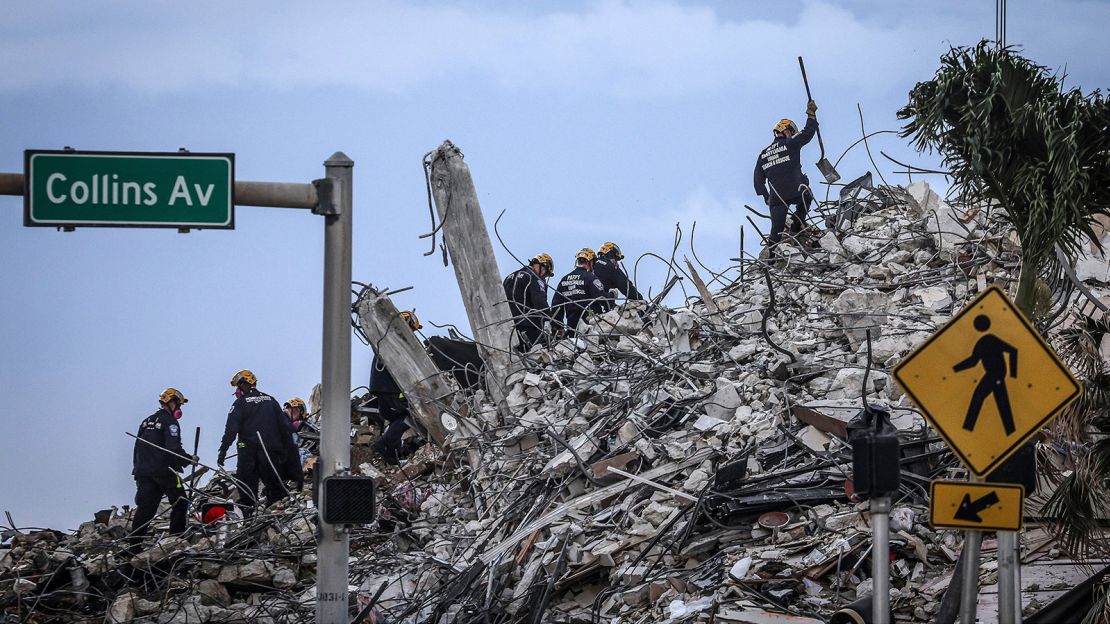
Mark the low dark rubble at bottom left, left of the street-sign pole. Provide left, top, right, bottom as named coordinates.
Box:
left=0, top=486, right=316, bottom=624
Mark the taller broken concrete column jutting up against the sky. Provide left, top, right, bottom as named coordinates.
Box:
left=431, top=141, right=513, bottom=405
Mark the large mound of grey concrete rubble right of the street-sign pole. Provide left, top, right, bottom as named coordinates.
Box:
left=337, top=176, right=1065, bottom=623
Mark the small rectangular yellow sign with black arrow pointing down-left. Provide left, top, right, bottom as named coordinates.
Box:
left=929, top=481, right=1026, bottom=531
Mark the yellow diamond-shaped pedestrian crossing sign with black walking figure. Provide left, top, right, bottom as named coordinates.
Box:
left=894, top=286, right=1081, bottom=476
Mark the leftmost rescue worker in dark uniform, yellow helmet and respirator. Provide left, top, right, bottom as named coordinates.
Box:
left=128, top=388, right=195, bottom=545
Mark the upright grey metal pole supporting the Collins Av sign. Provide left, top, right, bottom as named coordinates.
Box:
left=316, top=152, right=354, bottom=624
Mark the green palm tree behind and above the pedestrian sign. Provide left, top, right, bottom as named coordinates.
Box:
left=898, top=41, right=1110, bottom=316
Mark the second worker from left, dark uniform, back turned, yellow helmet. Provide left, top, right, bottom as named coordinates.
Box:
left=216, top=369, right=296, bottom=517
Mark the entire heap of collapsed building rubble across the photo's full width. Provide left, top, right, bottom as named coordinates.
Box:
left=0, top=170, right=1107, bottom=624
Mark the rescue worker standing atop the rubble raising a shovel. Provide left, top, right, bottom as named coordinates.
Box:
left=755, top=100, right=817, bottom=253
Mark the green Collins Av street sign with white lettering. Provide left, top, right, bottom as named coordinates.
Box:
left=23, top=150, right=235, bottom=230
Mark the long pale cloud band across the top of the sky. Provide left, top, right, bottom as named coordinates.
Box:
left=0, top=0, right=990, bottom=97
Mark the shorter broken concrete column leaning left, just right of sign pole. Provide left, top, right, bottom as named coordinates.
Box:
left=359, top=292, right=454, bottom=445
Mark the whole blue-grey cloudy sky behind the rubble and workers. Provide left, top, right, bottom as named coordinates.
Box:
left=0, top=0, right=1110, bottom=529
